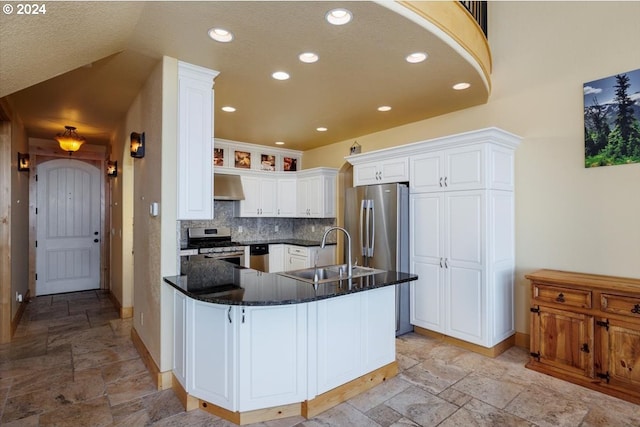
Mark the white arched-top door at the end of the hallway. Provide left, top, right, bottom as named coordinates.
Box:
left=36, top=159, right=101, bottom=295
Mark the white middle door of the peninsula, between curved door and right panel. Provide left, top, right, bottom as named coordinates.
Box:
left=238, top=304, right=307, bottom=411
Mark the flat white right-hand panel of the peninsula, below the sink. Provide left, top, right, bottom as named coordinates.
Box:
left=316, top=286, right=396, bottom=394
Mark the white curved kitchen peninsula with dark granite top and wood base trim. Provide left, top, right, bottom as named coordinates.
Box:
left=164, top=261, right=417, bottom=424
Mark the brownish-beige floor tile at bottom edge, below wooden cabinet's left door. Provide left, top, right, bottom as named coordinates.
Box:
left=505, top=385, right=589, bottom=427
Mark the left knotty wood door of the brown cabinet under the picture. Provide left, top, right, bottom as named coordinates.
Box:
left=531, top=306, right=594, bottom=378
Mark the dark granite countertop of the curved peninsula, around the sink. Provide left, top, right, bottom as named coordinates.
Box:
left=164, top=260, right=418, bottom=306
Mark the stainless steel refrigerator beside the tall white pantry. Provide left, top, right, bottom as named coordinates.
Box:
left=344, top=184, right=413, bottom=336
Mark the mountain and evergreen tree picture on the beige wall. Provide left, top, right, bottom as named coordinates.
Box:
left=583, top=69, right=640, bottom=168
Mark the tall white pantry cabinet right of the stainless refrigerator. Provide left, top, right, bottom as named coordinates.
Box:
left=409, top=129, right=517, bottom=348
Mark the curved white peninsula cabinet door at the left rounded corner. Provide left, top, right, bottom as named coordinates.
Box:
left=187, top=299, right=238, bottom=411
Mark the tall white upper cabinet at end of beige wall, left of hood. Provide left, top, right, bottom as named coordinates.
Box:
left=177, top=61, right=218, bottom=220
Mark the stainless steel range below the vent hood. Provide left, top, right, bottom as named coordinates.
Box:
left=181, top=227, right=247, bottom=270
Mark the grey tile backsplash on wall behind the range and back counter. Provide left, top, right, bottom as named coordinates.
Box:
left=180, top=200, right=336, bottom=244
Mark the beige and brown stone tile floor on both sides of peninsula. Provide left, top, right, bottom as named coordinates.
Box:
left=0, top=291, right=640, bottom=427
